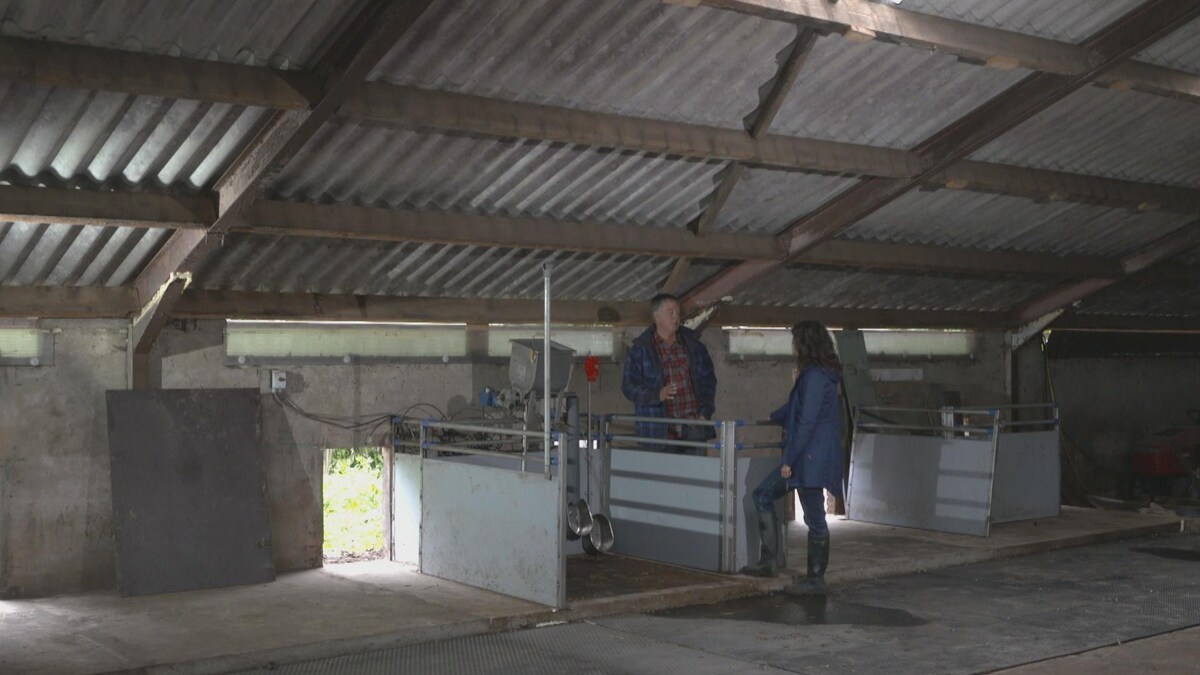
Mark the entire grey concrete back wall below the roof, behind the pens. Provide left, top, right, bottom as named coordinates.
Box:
left=0, top=321, right=1004, bottom=597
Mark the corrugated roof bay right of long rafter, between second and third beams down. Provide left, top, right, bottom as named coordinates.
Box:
left=840, top=190, right=1193, bottom=257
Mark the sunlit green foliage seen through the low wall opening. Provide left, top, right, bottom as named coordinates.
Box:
left=323, top=448, right=383, bottom=560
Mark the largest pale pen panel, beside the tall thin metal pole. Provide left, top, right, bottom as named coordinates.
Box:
left=421, top=459, right=565, bottom=607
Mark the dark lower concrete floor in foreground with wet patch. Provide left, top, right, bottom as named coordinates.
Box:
left=244, top=533, right=1200, bottom=675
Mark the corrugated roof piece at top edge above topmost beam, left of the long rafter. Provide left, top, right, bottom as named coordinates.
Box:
left=901, top=0, right=1141, bottom=44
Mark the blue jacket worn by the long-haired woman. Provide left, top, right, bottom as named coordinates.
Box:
left=770, top=366, right=845, bottom=495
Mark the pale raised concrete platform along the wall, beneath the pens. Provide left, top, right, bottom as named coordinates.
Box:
left=0, top=509, right=1181, bottom=675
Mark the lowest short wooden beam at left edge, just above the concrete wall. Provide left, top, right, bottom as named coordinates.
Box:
left=0, top=286, right=140, bottom=318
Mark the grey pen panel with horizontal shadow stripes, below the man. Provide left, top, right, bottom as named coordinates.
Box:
left=608, top=449, right=721, bottom=572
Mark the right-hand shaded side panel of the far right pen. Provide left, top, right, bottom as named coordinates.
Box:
left=991, top=430, right=1062, bottom=522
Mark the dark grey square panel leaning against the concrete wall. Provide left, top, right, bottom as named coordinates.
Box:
left=108, top=389, right=275, bottom=596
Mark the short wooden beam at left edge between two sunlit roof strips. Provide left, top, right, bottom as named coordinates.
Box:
left=0, top=185, right=216, bottom=229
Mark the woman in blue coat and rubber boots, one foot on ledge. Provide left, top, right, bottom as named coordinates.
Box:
left=742, top=321, right=842, bottom=595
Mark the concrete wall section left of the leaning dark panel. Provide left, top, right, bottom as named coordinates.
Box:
left=0, top=321, right=127, bottom=597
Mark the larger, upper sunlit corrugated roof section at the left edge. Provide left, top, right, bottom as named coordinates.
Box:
left=0, top=80, right=268, bottom=191
